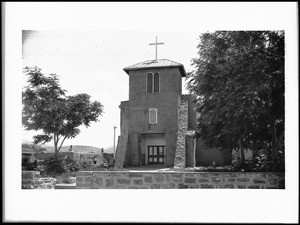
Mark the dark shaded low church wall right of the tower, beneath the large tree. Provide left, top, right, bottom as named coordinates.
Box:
left=196, top=141, right=232, bottom=166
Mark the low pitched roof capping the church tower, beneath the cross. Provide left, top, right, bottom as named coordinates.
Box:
left=123, top=59, right=186, bottom=77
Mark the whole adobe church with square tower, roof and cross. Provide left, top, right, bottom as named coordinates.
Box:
left=115, top=39, right=231, bottom=169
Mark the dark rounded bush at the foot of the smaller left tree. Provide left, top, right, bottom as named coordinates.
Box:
left=42, top=154, right=79, bottom=176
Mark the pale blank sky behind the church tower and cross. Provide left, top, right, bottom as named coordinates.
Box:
left=22, top=30, right=201, bottom=148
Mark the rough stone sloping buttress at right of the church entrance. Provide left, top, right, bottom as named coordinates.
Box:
left=174, top=99, right=188, bottom=168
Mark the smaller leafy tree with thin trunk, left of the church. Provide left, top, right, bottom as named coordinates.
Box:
left=22, top=67, right=103, bottom=154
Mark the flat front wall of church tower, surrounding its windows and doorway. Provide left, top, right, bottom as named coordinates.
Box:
left=128, top=68, right=182, bottom=166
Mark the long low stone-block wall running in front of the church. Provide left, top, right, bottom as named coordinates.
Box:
left=76, top=171, right=285, bottom=189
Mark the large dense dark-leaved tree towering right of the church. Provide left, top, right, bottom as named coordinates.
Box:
left=188, top=31, right=284, bottom=170
